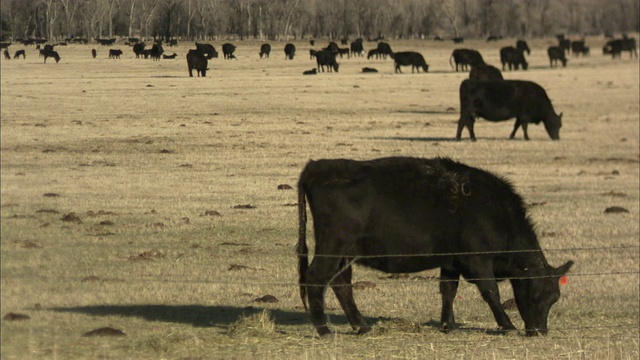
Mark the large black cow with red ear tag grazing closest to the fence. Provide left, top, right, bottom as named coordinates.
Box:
left=297, top=157, right=573, bottom=336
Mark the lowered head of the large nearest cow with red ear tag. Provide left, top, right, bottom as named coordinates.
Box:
left=511, top=261, right=573, bottom=336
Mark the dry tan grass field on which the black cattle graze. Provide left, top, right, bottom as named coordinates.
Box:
left=0, top=34, right=640, bottom=360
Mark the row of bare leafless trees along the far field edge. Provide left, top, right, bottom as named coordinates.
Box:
left=0, top=0, right=640, bottom=41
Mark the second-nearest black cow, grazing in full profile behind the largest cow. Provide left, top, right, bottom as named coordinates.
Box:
left=456, top=80, right=562, bottom=141
